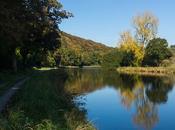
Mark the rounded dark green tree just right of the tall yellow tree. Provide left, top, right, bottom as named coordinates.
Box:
left=144, top=38, right=172, bottom=66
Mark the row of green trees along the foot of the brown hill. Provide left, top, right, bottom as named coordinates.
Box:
left=54, top=47, right=102, bottom=67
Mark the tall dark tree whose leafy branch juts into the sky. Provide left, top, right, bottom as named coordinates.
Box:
left=21, top=0, right=72, bottom=66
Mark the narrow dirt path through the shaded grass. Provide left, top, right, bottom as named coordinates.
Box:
left=0, top=77, right=29, bottom=113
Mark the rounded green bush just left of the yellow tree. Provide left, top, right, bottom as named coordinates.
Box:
left=102, top=49, right=123, bottom=69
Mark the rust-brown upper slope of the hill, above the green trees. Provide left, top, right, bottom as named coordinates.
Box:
left=61, top=32, right=112, bottom=52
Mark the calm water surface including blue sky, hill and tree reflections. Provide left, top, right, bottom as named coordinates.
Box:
left=66, top=69, right=175, bottom=130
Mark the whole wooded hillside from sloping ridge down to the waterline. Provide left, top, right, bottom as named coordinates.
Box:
left=59, top=32, right=113, bottom=66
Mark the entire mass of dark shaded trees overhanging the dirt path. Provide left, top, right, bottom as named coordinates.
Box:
left=0, top=0, right=72, bottom=71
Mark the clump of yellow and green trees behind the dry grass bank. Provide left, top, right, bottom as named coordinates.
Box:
left=103, top=12, right=173, bottom=67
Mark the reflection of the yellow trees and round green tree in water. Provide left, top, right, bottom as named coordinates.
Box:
left=117, top=75, right=174, bottom=130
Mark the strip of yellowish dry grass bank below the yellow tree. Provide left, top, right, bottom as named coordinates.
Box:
left=117, top=67, right=175, bottom=76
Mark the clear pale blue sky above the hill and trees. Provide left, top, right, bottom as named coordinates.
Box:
left=60, top=0, right=175, bottom=47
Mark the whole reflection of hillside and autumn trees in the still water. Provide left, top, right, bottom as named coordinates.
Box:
left=66, top=69, right=174, bottom=130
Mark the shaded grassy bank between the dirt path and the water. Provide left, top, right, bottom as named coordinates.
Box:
left=0, top=70, right=94, bottom=130
